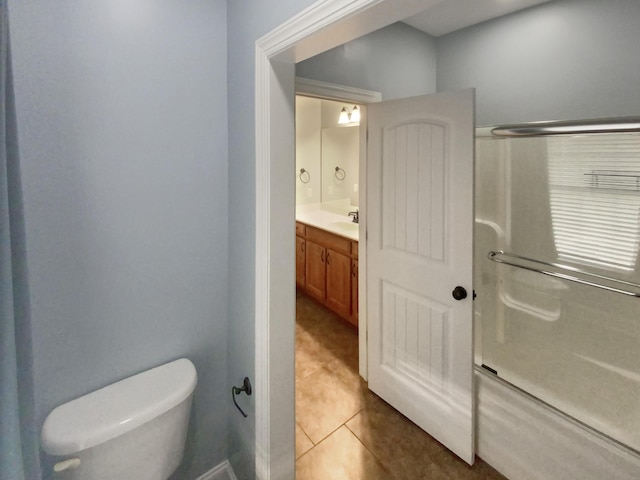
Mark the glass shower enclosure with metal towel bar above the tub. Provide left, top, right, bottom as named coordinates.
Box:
left=474, top=120, right=640, bottom=452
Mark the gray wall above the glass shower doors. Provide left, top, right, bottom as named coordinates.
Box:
left=436, top=0, right=640, bottom=125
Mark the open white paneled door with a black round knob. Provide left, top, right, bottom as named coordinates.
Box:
left=367, top=90, right=475, bottom=464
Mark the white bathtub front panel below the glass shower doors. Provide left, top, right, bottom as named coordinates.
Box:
left=475, top=370, right=640, bottom=480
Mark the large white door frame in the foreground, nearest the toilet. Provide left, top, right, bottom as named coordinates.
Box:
left=254, top=0, right=440, bottom=480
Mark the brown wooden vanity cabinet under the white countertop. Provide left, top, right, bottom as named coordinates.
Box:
left=296, top=222, right=358, bottom=326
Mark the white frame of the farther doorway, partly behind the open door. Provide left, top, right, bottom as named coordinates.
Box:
left=295, top=77, right=382, bottom=380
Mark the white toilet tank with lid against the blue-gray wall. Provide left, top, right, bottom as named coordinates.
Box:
left=42, top=358, right=197, bottom=480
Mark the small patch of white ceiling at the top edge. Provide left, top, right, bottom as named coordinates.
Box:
left=404, top=0, right=549, bottom=37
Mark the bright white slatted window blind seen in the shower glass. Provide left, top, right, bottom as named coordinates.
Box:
left=547, top=134, right=640, bottom=271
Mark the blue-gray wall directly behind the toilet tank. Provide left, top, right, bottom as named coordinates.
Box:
left=9, top=0, right=230, bottom=478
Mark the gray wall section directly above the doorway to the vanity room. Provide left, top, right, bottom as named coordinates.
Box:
left=296, top=23, right=436, bottom=100
